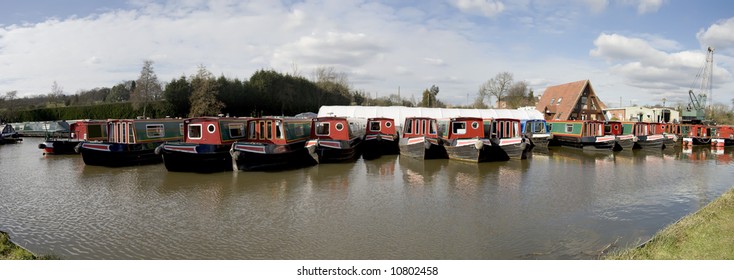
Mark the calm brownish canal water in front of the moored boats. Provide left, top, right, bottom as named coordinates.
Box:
left=0, top=138, right=734, bottom=260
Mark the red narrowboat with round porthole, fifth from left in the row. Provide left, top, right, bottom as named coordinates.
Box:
left=306, top=117, right=367, bottom=163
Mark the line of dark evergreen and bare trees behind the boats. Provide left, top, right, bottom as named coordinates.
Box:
left=0, top=60, right=548, bottom=122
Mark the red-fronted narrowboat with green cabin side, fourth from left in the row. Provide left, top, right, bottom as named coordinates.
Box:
left=231, top=117, right=315, bottom=170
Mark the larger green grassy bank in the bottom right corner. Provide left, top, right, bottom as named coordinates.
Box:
left=605, top=188, right=734, bottom=260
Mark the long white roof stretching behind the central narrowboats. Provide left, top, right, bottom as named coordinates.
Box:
left=318, top=106, right=545, bottom=121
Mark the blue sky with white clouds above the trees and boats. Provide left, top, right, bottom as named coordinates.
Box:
left=0, top=0, right=734, bottom=106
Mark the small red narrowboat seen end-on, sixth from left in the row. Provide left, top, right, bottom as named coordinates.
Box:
left=362, top=118, right=400, bottom=159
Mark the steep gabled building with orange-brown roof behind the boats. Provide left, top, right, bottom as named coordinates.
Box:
left=535, top=80, right=606, bottom=121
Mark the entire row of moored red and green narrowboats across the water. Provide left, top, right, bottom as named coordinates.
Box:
left=20, top=112, right=734, bottom=173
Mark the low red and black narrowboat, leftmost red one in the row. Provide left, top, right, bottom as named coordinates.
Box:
left=38, top=120, right=107, bottom=155
